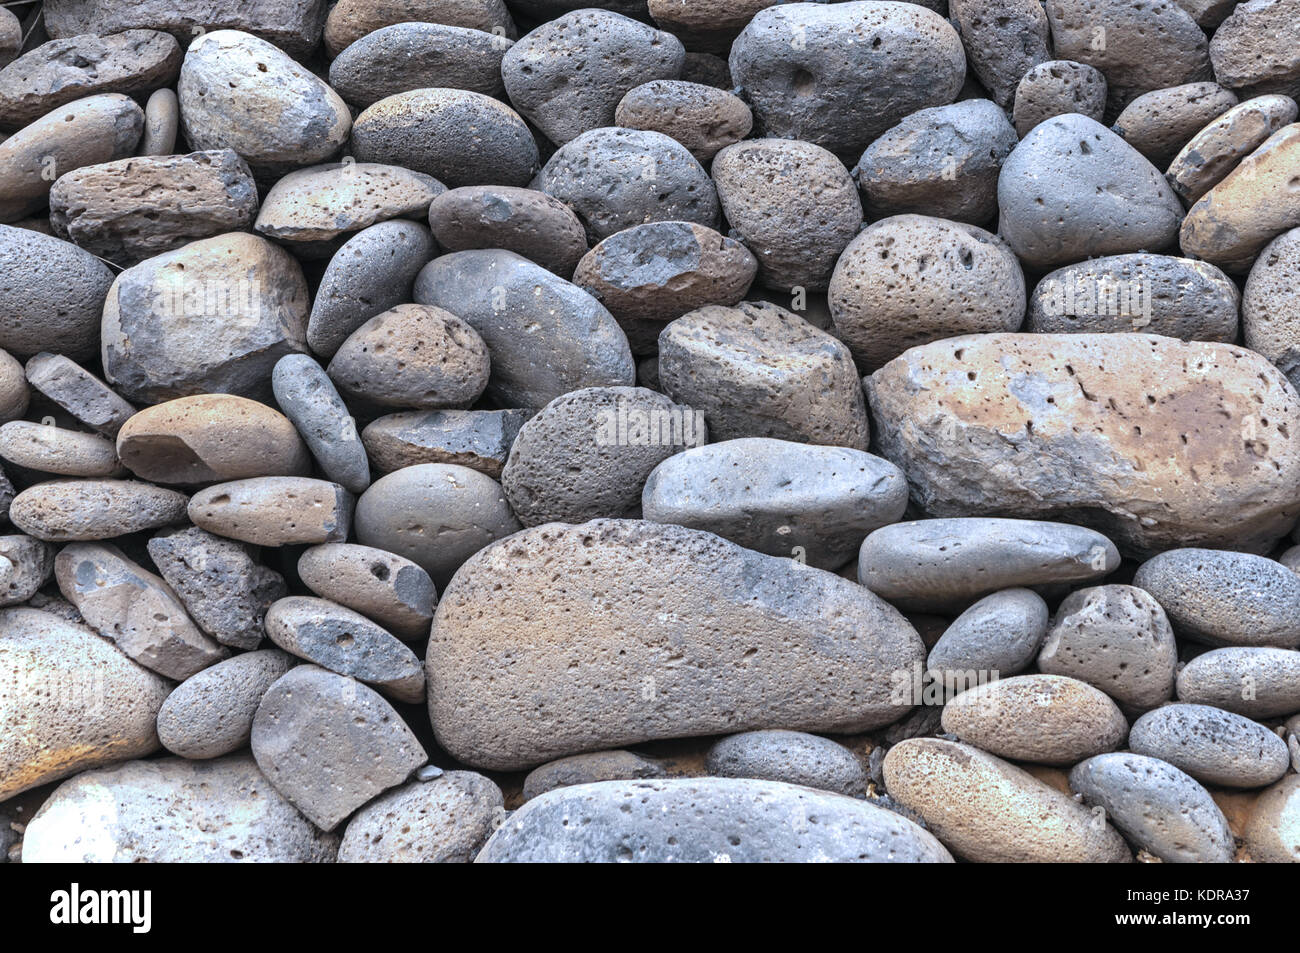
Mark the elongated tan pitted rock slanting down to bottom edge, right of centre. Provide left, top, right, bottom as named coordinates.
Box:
left=884, top=738, right=1132, bottom=863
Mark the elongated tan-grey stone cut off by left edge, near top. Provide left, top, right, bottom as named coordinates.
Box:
left=0, top=92, right=144, bottom=222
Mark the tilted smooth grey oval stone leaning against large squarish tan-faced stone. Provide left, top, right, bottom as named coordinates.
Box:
left=307, top=220, right=437, bottom=360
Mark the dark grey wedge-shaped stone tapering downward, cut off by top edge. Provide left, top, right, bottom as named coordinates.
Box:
left=948, top=0, right=1052, bottom=108
